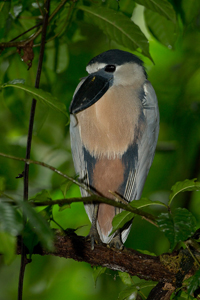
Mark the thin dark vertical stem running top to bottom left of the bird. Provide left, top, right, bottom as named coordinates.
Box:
left=18, top=0, right=50, bottom=300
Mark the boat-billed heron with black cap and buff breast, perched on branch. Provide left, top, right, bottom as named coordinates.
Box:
left=70, top=49, right=159, bottom=249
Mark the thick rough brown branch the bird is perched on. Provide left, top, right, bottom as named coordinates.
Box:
left=17, top=233, right=194, bottom=288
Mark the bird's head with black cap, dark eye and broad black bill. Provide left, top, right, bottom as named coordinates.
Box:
left=69, top=49, right=147, bottom=114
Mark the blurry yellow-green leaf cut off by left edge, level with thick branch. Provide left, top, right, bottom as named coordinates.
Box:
left=0, top=231, right=17, bottom=264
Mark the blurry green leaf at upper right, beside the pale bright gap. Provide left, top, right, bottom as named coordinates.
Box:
left=144, top=9, right=177, bottom=48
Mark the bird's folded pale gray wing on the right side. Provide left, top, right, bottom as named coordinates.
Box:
left=122, top=81, right=160, bottom=242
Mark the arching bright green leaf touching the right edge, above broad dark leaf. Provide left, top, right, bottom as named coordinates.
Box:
left=168, top=178, right=200, bottom=206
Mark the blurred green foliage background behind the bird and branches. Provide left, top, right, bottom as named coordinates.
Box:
left=0, top=0, right=200, bottom=300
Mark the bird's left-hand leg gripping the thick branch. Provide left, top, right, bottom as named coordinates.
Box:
left=87, top=204, right=101, bottom=250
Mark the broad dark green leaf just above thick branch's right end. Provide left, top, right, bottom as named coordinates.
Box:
left=157, top=207, right=196, bottom=250
